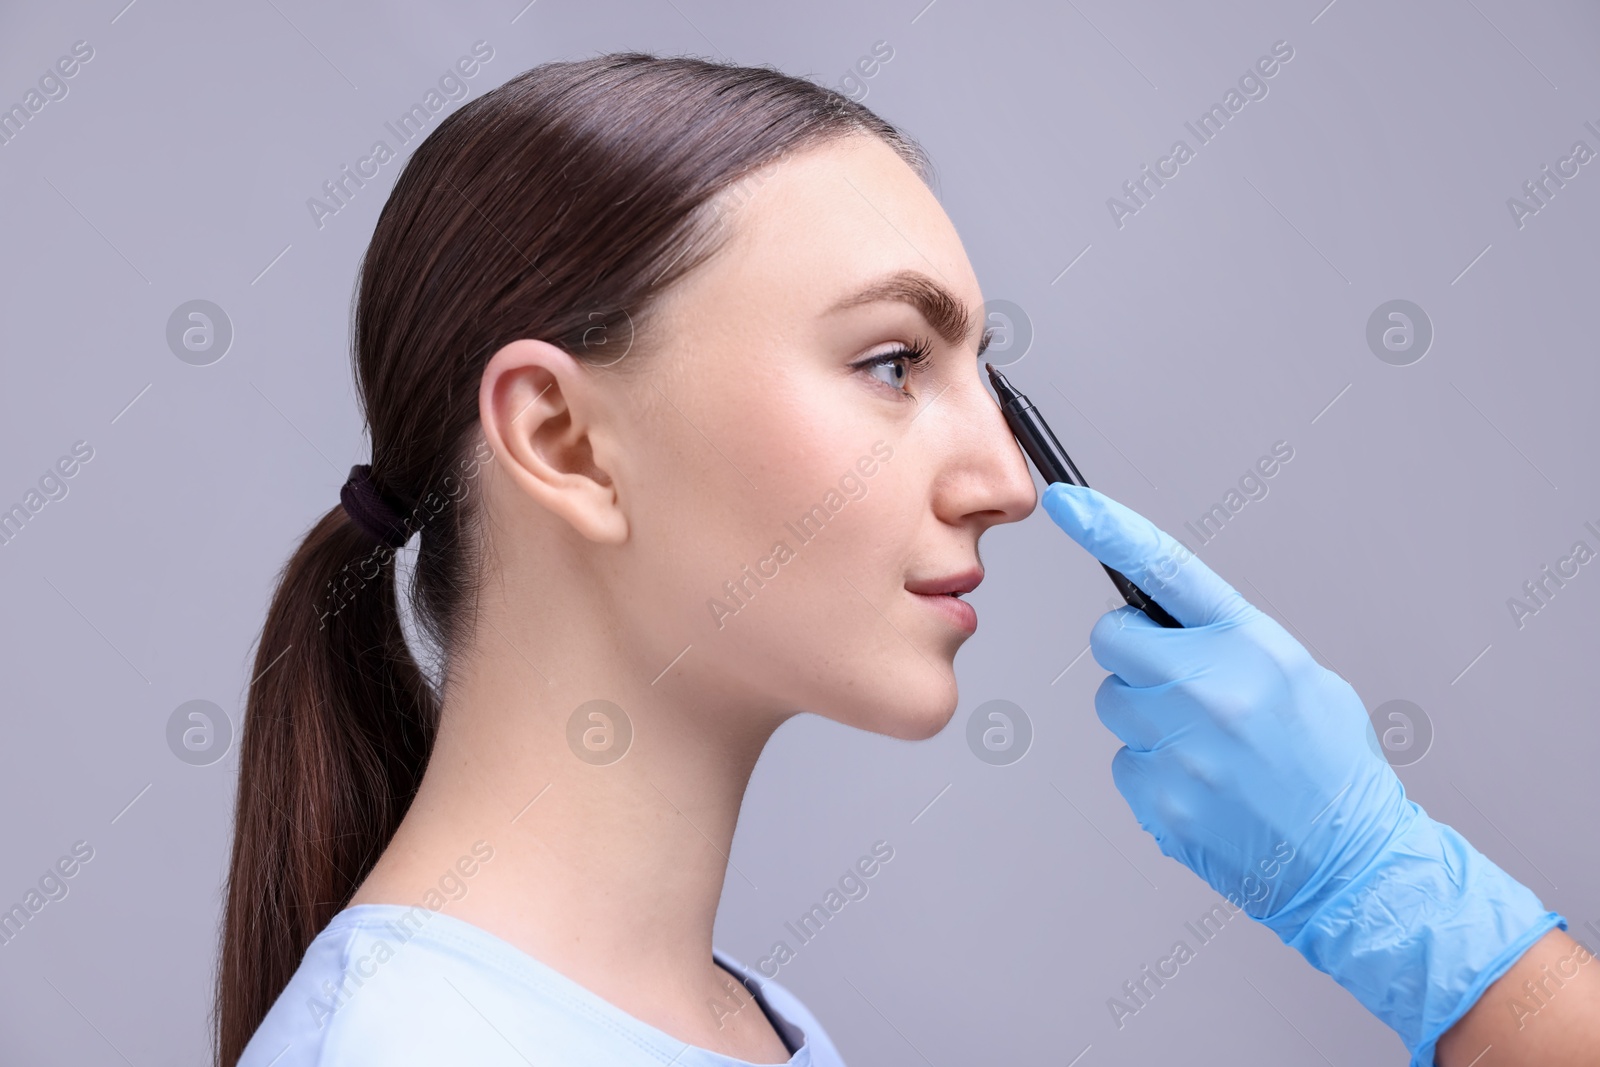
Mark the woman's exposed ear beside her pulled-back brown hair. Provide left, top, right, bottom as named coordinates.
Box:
left=478, top=339, right=627, bottom=544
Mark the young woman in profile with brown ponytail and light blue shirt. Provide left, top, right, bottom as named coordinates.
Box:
left=218, top=54, right=1579, bottom=1067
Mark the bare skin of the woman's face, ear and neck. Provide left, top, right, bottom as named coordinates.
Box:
left=352, top=136, right=1037, bottom=1064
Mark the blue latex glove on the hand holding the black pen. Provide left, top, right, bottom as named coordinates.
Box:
left=1043, top=482, right=1566, bottom=1067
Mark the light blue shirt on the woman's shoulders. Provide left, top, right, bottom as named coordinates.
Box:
left=238, top=904, right=845, bottom=1067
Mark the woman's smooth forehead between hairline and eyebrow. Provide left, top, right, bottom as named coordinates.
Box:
left=678, top=134, right=982, bottom=334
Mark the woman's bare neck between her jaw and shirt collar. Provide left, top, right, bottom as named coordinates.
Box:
left=352, top=591, right=781, bottom=1033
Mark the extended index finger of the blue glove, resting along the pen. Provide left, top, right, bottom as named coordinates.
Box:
left=1042, top=482, right=1250, bottom=627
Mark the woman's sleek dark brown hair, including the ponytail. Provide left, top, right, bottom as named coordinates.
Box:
left=214, top=53, right=933, bottom=1067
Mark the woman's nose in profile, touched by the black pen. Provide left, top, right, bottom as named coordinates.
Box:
left=926, top=360, right=1038, bottom=533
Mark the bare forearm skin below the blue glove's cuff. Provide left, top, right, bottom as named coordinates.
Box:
left=1434, top=929, right=1600, bottom=1067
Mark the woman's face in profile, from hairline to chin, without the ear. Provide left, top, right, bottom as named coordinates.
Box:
left=611, top=129, right=1037, bottom=739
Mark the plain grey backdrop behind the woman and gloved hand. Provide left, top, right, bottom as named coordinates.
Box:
left=0, top=0, right=1600, bottom=1067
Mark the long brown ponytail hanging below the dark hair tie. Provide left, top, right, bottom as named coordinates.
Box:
left=216, top=506, right=438, bottom=1067
